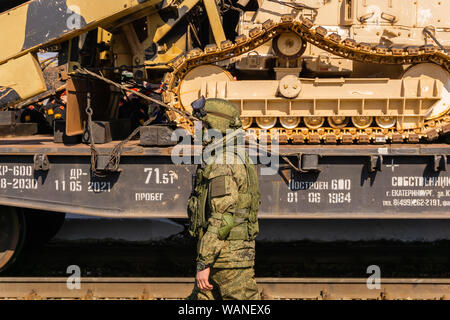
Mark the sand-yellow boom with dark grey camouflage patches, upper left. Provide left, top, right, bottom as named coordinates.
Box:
left=0, top=0, right=161, bottom=106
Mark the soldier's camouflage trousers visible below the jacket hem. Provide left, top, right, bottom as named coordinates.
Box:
left=187, top=267, right=260, bottom=300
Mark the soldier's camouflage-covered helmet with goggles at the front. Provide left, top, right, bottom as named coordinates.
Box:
left=192, top=96, right=242, bottom=133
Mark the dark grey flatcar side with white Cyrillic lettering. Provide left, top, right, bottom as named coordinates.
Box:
left=0, top=136, right=450, bottom=219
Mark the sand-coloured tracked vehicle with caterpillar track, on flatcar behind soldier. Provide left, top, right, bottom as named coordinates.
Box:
left=165, top=0, right=450, bottom=143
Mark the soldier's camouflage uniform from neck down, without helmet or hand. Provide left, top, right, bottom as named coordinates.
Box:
left=189, top=97, right=260, bottom=300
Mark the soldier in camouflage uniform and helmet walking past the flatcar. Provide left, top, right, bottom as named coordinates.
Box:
left=188, top=97, right=260, bottom=300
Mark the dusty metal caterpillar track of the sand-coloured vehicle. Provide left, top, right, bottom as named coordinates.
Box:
left=163, top=15, right=450, bottom=144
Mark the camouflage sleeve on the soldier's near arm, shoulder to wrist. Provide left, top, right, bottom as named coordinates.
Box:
left=197, top=164, right=245, bottom=265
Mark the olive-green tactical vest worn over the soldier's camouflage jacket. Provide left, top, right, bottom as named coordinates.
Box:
left=188, top=154, right=260, bottom=240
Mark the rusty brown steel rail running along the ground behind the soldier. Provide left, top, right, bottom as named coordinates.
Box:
left=0, top=277, right=450, bottom=300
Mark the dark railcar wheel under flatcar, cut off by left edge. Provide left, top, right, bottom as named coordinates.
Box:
left=0, top=206, right=26, bottom=272
